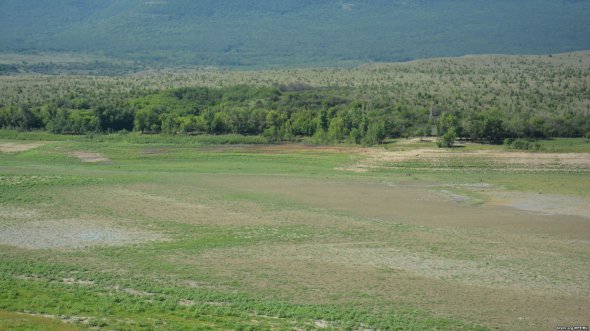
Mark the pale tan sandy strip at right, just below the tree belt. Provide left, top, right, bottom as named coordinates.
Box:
left=338, top=148, right=590, bottom=172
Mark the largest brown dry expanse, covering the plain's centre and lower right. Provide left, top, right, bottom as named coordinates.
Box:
left=35, top=175, right=590, bottom=330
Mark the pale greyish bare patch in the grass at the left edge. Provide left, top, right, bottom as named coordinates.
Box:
left=0, top=219, right=163, bottom=249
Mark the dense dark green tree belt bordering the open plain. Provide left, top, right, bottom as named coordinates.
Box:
left=0, top=84, right=590, bottom=146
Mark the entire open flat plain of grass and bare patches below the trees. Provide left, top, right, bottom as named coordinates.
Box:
left=0, top=131, right=590, bottom=330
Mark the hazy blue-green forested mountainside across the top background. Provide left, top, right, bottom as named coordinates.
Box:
left=0, top=0, right=590, bottom=68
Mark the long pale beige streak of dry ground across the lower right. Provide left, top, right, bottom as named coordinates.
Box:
left=232, top=241, right=590, bottom=296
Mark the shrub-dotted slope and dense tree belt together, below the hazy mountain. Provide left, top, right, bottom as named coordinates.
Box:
left=0, top=52, right=590, bottom=145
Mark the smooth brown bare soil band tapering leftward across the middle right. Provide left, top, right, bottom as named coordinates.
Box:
left=205, top=176, right=590, bottom=239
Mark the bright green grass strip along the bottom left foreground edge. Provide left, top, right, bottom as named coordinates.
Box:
left=0, top=277, right=485, bottom=330
